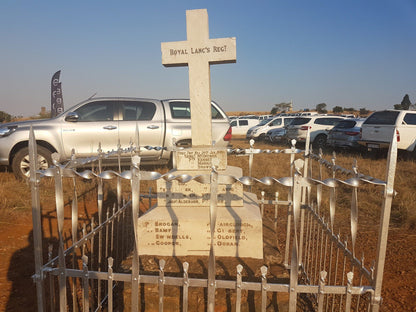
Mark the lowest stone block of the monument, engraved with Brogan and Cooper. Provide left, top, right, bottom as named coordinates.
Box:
left=138, top=192, right=263, bottom=259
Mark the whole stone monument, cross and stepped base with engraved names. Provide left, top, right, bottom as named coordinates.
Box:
left=138, top=10, right=263, bottom=259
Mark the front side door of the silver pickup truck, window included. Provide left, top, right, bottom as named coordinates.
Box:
left=62, top=100, right=118, bottom=157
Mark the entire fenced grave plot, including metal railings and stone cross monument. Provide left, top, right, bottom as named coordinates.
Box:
left=29, top=10, right=397, bottom=311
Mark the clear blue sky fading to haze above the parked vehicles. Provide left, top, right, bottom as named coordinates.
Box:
left=0, top=0, right=416, bottom=116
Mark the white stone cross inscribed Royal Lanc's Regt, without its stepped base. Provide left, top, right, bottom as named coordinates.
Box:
left=161, top=9, right=236, bottom=147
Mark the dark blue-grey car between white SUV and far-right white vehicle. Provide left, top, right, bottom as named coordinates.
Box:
left=327, top=118, right=365, bottom=148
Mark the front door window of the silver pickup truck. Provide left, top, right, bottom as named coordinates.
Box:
left=75, top=101, right=116, bottom=122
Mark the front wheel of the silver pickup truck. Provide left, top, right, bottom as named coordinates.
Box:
left=12, top=145, right=52, bottom=180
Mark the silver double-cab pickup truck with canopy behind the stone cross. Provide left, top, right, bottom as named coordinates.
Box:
left=0, top=98, right=231, bottom=178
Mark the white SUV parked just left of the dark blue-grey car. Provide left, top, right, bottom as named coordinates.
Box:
left=286, top=115, right=344, bottom=147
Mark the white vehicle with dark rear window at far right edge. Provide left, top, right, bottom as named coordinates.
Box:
left=359, top=110, right=416, bottom=153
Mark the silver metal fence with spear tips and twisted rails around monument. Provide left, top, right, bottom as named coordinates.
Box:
left=29, top=125, right=397, bottom=312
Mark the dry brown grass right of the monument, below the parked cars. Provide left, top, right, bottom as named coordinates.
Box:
left=229, top=138, right=416, bottom=229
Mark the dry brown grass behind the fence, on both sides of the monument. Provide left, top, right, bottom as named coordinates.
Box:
left=0, top=138, right=416, bottom=229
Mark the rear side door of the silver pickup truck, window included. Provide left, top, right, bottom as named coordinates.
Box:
left=119, top=100, right=165, bottom=159
